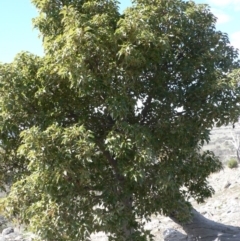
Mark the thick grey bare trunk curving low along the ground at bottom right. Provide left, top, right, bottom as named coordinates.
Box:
left=164, top=209, right=240, bottom=241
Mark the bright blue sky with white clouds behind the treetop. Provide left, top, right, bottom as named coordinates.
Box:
left=0, top=0, right=240, bottom=62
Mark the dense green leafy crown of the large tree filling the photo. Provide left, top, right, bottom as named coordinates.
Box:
left=0, top=0, right=239, bottom=241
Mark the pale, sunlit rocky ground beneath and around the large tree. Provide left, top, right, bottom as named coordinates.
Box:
left=0, top=167, right=240, bottom=241
